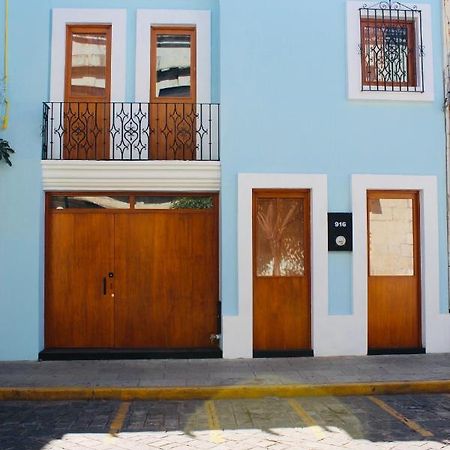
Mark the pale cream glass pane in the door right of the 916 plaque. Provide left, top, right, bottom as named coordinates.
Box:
left=368, top=198, right=414, bottom=276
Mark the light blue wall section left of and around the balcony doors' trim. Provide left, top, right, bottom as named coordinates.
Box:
left=0, top=0, right=219, bottom=360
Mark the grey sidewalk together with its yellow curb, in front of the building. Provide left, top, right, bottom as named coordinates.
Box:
left=0, top=354, right=450, bottom=399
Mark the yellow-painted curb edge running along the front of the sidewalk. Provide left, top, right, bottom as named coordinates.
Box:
left=0, top=380, right=450, bottom=401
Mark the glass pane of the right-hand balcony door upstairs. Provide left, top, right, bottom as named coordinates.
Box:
left=156, top=33, right=192, bottom=98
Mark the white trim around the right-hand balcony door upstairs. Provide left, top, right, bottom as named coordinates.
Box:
left=135, top=9, right=211, bottom=103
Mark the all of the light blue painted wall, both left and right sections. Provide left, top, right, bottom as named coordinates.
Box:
left=0, top=0, right=447, bottom=360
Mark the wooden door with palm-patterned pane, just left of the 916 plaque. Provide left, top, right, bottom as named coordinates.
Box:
left=253, top=190, right=311, bottom=352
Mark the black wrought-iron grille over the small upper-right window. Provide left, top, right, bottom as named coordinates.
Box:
left=359, top=0, right=425, bottom=92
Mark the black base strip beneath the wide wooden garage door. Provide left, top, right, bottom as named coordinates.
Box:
left=39, top=348, right=222, bottom=361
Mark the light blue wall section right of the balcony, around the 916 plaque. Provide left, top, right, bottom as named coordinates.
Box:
left=220, top=0, right=448, bottom=315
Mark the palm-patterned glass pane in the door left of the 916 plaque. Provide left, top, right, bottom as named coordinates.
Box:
left=255, top=198, right=305, bottom=277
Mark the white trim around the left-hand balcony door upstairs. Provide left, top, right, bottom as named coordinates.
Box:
left=50, top=8, right=127, bottom=102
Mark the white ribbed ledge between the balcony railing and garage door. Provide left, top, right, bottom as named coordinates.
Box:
left=41, top=160, right=220, bottom=192
